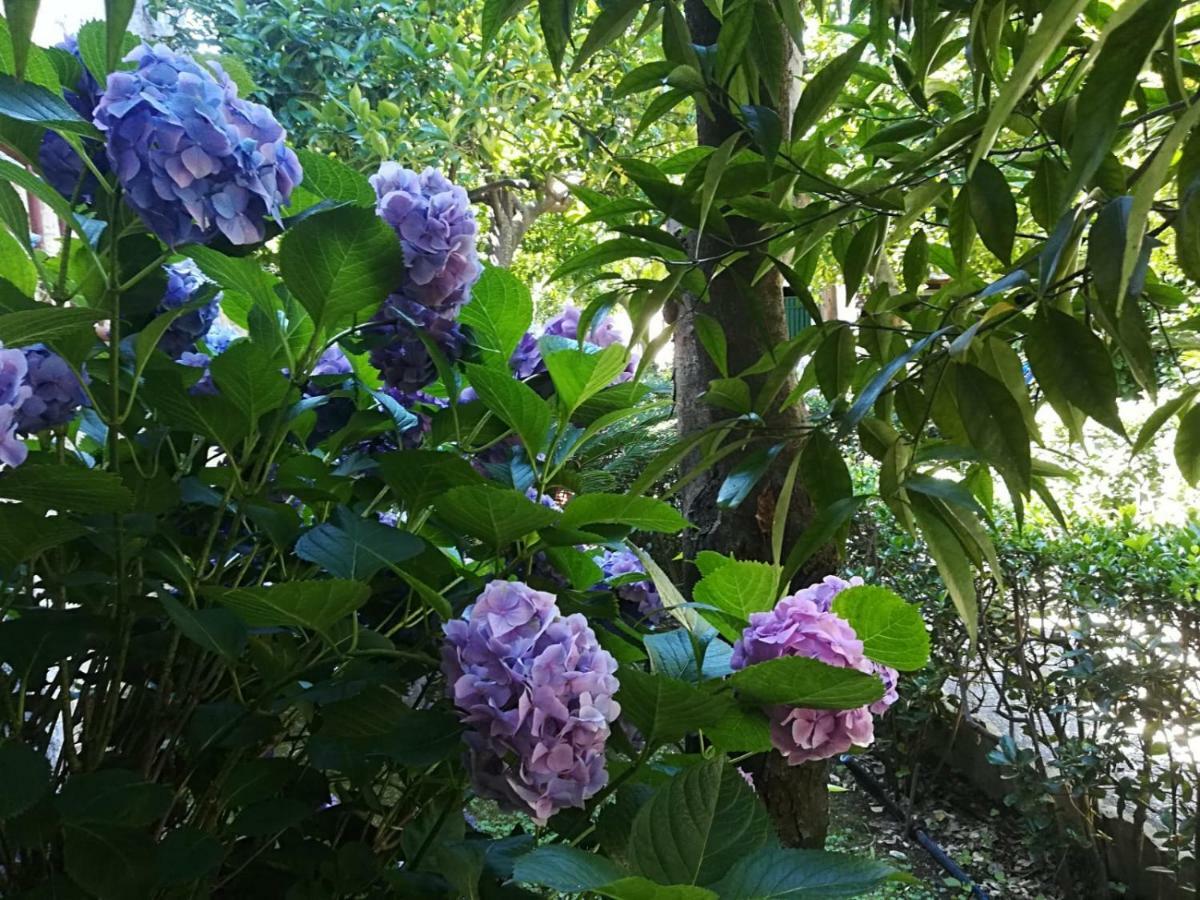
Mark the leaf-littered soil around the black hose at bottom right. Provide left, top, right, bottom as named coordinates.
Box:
left=826, top=757, right=1062, bottom=900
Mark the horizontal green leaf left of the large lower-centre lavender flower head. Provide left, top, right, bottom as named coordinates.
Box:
left=204, top=580, right=371, bottom=631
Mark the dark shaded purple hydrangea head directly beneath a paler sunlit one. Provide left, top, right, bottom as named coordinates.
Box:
left=371, top=294, right=467, bottom=392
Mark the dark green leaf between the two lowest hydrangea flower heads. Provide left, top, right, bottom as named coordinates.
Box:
left=617, top=667, right=724, bottom=746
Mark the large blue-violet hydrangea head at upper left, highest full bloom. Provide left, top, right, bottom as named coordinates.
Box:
left=95, top=44, right=302, bottom=246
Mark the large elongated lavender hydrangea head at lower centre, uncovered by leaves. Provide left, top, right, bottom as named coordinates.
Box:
left=442, top=581, right=620, bottom=823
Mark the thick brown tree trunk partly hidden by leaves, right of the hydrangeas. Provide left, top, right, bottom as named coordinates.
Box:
left=674, top=0, right=834, bottom=847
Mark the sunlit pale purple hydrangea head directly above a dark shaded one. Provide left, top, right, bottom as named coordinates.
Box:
left=371, top=162, right=482, bottom=316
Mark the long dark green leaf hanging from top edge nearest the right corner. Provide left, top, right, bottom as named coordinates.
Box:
left=1068, top=0, right=1178, bottom=200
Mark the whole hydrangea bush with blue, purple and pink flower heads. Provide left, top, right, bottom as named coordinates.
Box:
left=0, top=14, right=924, bottom=900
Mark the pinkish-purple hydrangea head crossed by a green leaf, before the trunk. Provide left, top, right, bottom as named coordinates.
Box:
left=730, top=576, right=899, bottom=766
